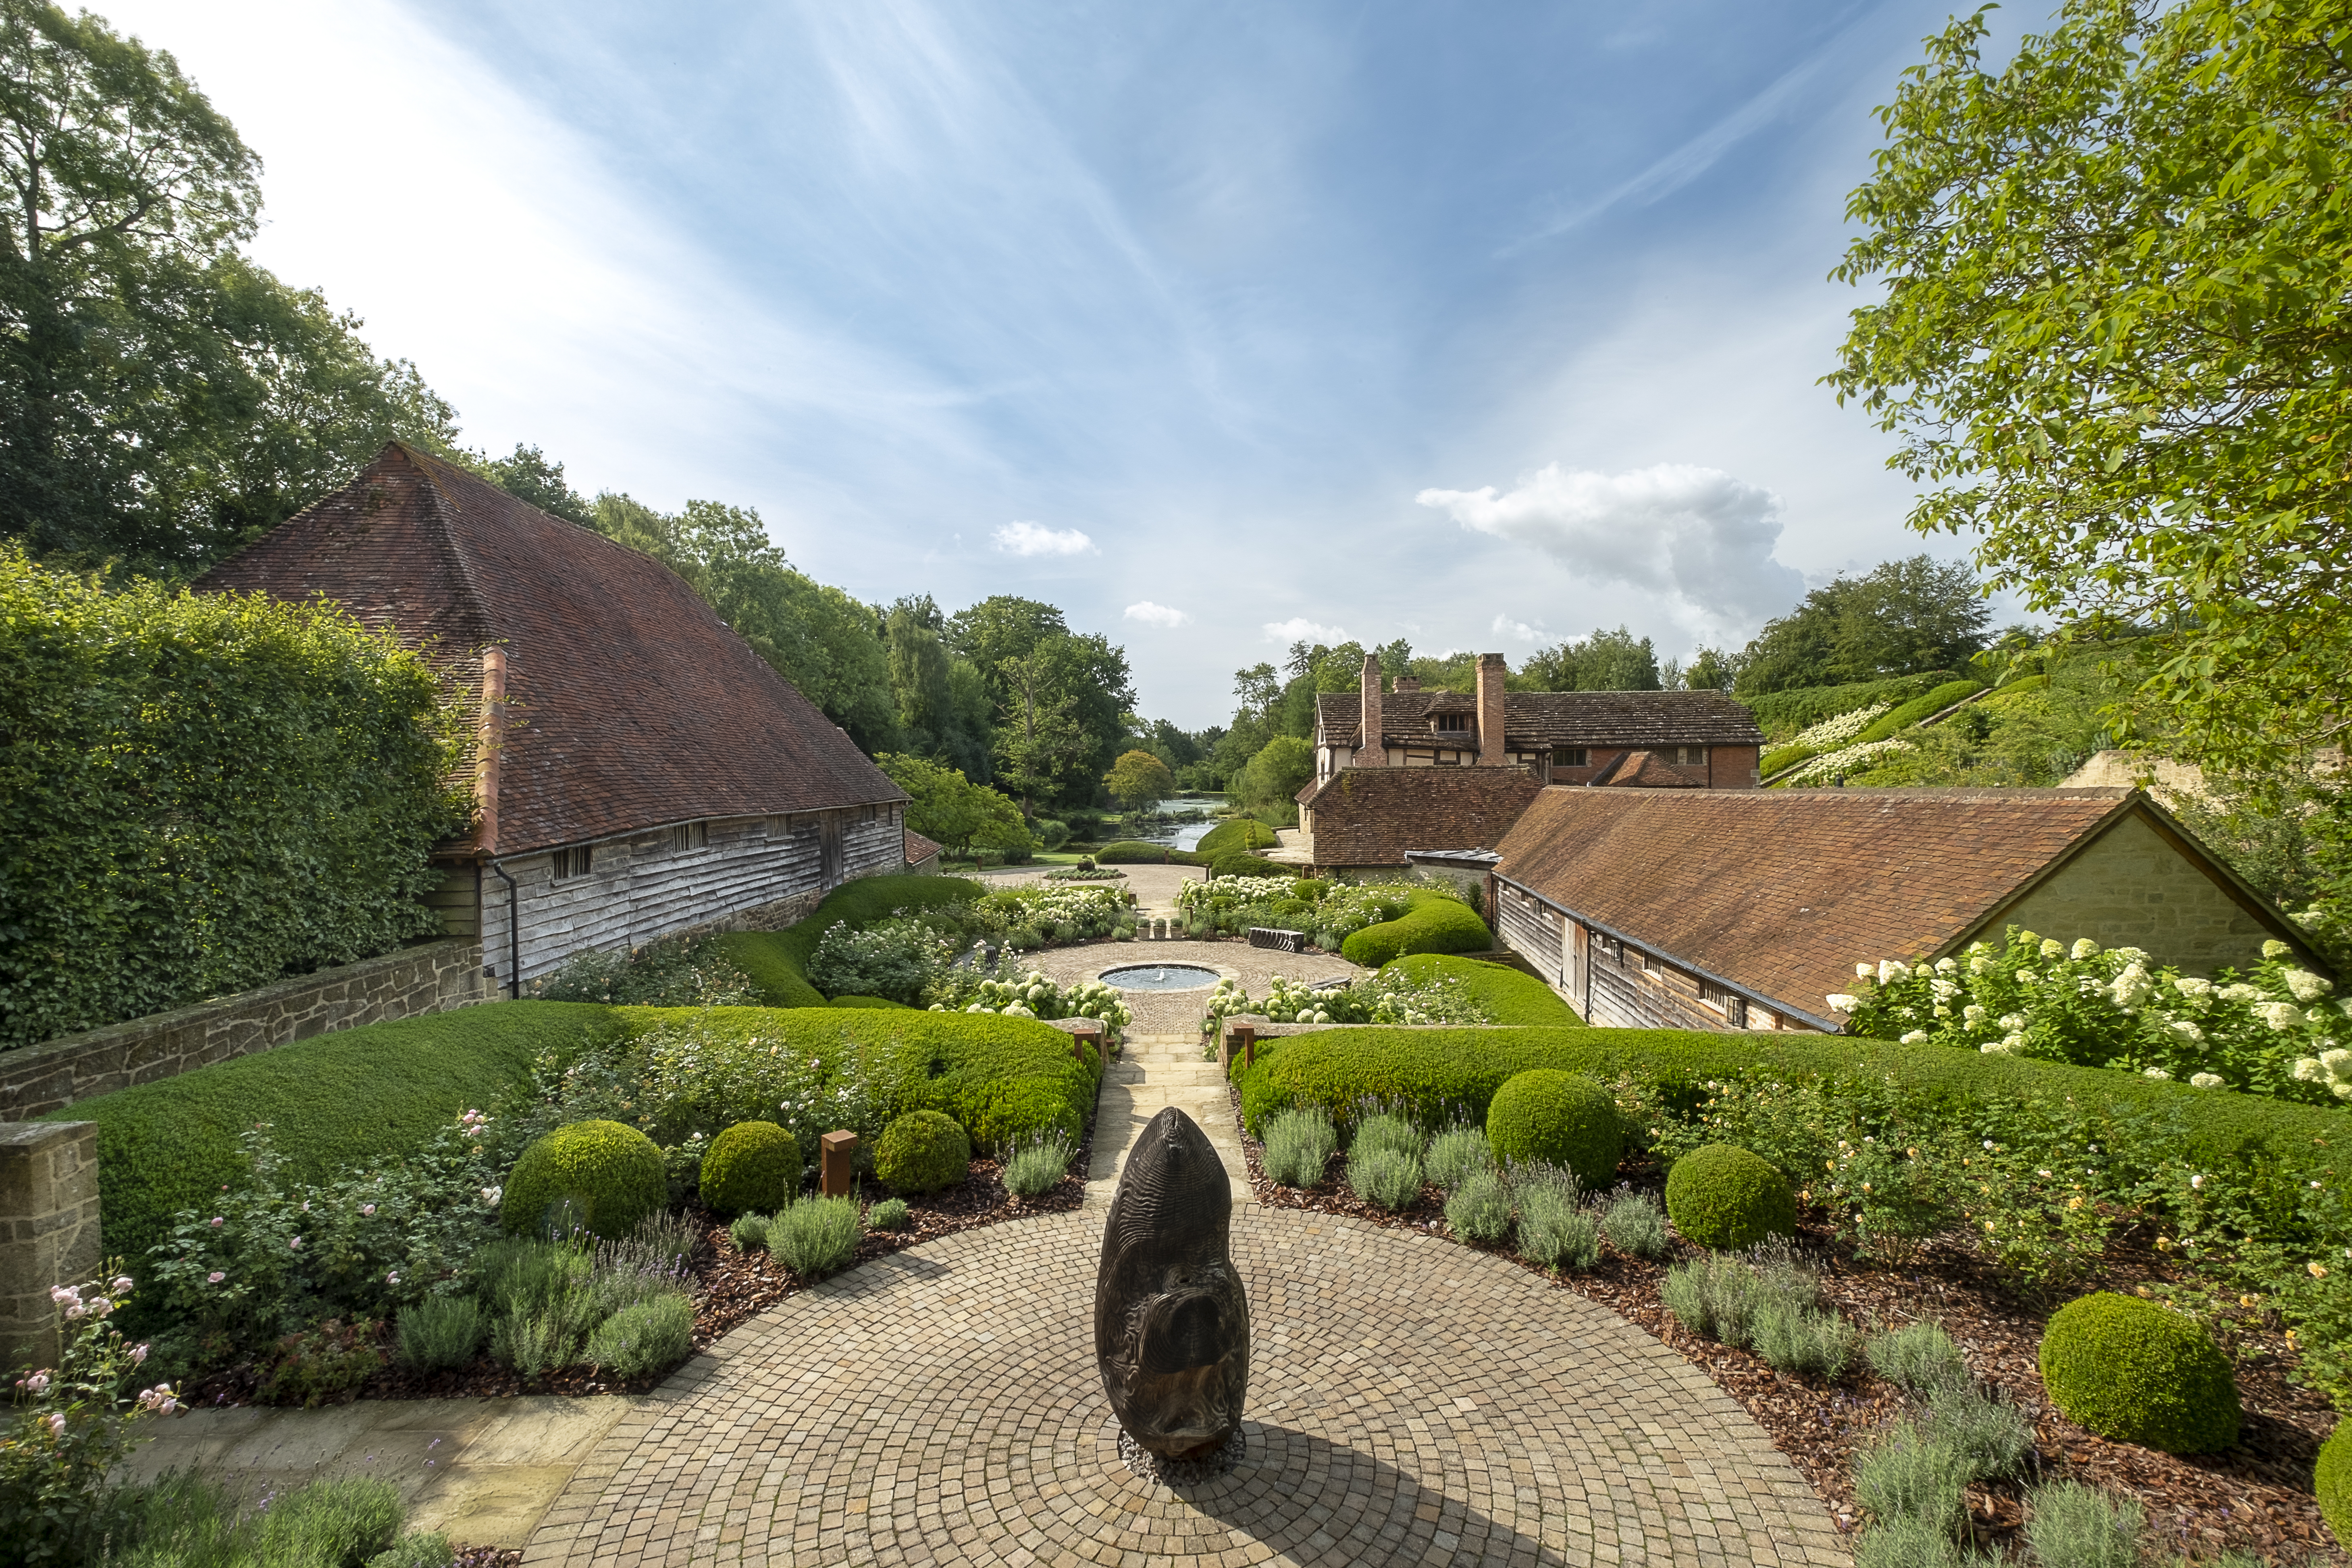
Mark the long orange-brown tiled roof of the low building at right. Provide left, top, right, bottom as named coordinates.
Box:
left=1501, top=785, right=2140, bottom=1018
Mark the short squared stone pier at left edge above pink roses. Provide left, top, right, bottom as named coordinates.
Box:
left=0, top=1121, right=104, bottom=1368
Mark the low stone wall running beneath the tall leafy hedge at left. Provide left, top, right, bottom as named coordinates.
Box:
left=0, top=938, right=494, bottom=1121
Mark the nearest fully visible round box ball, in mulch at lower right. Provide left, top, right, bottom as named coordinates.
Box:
left=2042, top=1291, right=2239, bottom=1453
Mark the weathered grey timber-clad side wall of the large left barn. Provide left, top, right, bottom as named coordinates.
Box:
left=482, top=806, right=905, bottom=985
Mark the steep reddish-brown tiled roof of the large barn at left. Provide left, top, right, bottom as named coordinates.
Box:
left=198, top=442, right=905, bottom=853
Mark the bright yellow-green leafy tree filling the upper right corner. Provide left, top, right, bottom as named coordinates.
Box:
left=1828, top=0, right=2352, bottom=769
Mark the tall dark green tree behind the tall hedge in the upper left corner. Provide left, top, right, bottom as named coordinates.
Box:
left=0, top=0, right=456, bottom=576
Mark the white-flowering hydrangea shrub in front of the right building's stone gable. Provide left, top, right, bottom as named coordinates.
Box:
left=1828, top=926, right=2352, bottom=1102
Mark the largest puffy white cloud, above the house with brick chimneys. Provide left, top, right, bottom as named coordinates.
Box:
left=1414, top=463, right=1804, bottom=637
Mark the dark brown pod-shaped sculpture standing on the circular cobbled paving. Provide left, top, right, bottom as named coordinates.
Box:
left=1094, top=1105, right=1249, bottom=1460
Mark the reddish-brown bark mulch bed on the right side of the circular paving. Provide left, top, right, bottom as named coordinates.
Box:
left=1235, top=1096, right=2352, bottom=1568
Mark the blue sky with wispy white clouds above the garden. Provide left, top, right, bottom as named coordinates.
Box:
left=94, top=0, right=2041, bottom=729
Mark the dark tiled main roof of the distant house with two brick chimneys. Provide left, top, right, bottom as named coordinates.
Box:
left=1315, top=691, right=1764, bottom=752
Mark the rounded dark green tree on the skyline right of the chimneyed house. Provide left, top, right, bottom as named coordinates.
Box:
left=1738, top=555, right=1992, bottom=696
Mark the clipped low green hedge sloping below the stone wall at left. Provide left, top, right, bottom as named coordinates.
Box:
left=45, top=1001, right=619, bottom=1267
